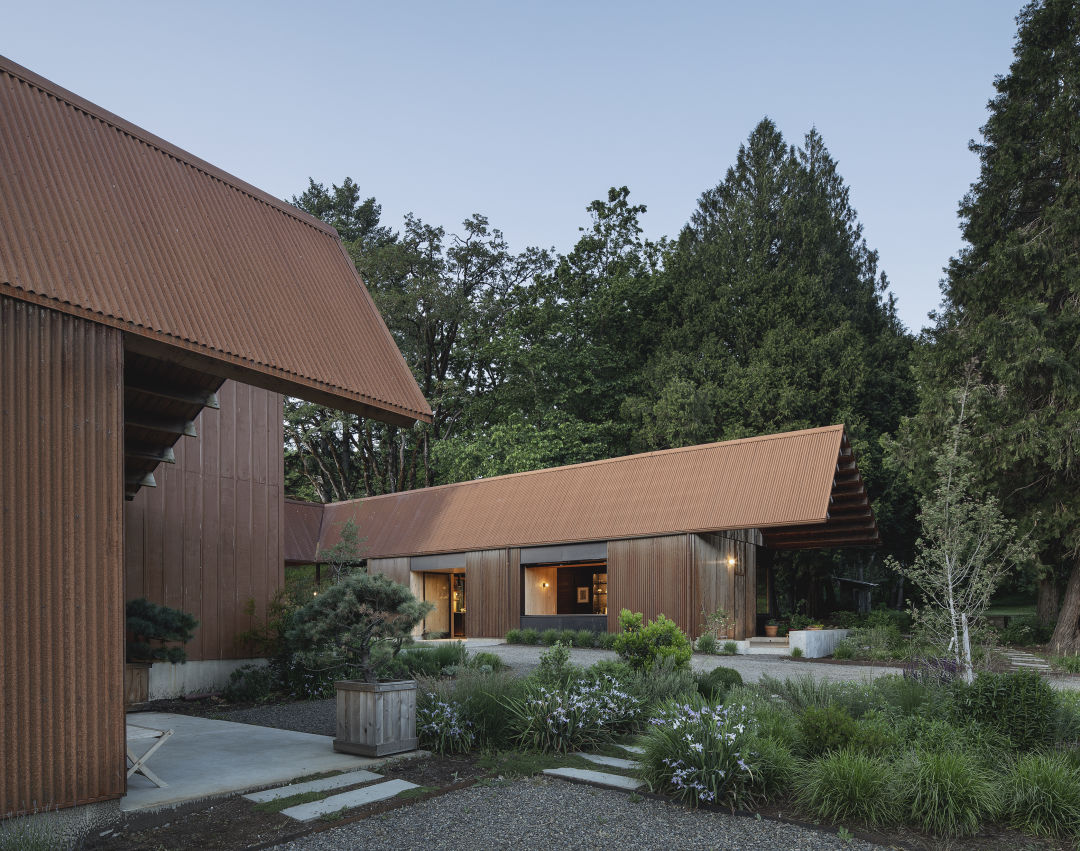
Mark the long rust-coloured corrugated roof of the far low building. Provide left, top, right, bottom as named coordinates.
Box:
left=320, top=426, right=877, bottom=558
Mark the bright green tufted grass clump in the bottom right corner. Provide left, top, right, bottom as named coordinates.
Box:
left=1003, top=754, right=1080, bottom=836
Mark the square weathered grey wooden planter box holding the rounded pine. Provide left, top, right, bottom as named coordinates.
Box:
left=334, top=679, right=418, bottom=756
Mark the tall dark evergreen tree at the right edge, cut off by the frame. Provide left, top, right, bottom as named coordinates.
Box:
left=905, top=0, right=1080, bottom=652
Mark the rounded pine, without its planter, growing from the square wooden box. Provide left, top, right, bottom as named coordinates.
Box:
left=289, top=573, right=434, bottom=683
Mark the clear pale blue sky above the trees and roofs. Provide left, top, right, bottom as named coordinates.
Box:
left=6, top=0, right=1022, bottom=329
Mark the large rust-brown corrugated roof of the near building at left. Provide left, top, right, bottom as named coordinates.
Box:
left=0, top=57, right=431, bottom=423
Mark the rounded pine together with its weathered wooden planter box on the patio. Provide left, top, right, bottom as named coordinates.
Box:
left=291, top=572, right=432, bottom=756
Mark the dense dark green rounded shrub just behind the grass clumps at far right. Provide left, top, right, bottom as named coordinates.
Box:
left=953, top=671, right=1057, bottom=751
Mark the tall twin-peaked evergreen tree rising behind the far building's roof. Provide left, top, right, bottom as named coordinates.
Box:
left=624, top=119, right=913, bottom=603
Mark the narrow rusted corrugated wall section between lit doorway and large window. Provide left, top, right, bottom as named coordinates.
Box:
left=465, top=548, right=522, bottom=638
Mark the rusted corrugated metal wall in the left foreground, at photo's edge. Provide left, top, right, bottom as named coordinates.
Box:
left=0, top=297, right=125, bottom=814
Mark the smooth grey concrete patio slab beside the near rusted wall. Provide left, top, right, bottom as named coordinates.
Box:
left=120, top=712, right=386, bottom=812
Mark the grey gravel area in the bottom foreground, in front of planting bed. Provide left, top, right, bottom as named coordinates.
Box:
left=272, top=778, right=881, bottom=851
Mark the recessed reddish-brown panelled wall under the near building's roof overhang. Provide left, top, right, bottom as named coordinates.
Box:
left=124, top=381, right=285, bottom=661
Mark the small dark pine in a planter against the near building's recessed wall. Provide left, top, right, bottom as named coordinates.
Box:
left=124, top=597, right=199, bottom=706
